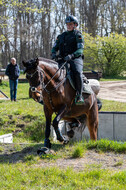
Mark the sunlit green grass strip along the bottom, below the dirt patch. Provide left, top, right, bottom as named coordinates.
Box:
left=0, top=163, right=126, bottom=190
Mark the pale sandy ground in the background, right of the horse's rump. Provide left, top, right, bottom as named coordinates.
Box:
left=98, top=81, right=126, bottom=102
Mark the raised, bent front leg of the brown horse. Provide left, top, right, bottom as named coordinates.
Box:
left=53, top=105, right=67, bottom=142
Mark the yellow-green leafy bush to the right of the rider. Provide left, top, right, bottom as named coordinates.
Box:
left=84, top=33, right=126, bottom=76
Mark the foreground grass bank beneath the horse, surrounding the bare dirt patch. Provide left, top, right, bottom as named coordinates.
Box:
left=0, top=140, right=126, bottom=190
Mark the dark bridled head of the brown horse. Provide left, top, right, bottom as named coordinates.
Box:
left=22, top=58, right=41, bottom=102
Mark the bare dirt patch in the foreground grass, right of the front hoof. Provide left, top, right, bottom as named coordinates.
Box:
left=36, top=150, right=126, bottom=171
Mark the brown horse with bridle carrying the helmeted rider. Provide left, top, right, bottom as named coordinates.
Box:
left=23, top=58, right=101, bottom=148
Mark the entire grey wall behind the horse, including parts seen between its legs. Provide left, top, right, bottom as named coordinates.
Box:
left=52, top=112, right=126, bottom=141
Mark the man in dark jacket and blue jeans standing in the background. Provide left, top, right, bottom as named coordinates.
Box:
left=5, top=57, right=20, bottom=101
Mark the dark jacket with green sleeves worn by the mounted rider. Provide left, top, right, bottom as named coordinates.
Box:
left=52, top=30, right=84, bottom=58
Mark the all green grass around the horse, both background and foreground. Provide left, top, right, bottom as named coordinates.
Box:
left=0, top=79, right=126, bottom=190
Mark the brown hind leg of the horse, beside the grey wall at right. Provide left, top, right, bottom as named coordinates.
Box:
left=87, top=105, right=98, bottom=140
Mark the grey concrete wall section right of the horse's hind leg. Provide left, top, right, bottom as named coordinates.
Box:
left=98, top=112, right=126, bottom=141
